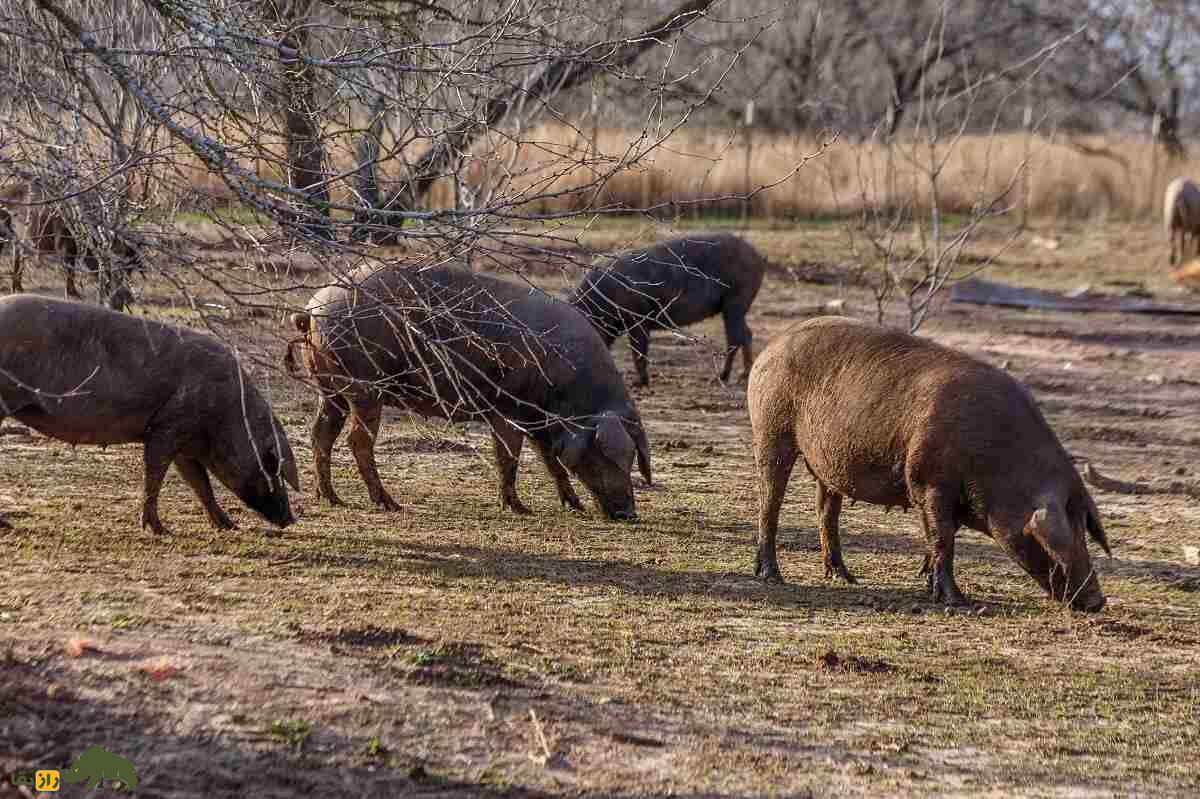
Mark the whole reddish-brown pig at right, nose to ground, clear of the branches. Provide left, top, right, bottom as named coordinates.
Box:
left=748, top=317, right=1111, bottom=612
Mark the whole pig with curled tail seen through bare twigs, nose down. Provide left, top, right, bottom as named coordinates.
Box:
left=288, top=265, right=650, bottom=521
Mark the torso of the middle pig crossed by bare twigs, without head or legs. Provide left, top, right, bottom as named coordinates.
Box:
left=308, top=268, right=624, bottom=421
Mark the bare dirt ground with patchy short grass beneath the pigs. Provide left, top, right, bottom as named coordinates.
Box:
left=0, top=214, right=1200, bottom=798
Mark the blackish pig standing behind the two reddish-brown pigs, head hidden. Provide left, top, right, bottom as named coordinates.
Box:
left=568, top=233, right=767, bottom=385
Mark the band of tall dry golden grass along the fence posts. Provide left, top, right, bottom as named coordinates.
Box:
left=157, top=119, right=1200, bottom=218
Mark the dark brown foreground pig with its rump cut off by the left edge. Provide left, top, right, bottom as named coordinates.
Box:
left=0, top=294, right=299, bottom=527
